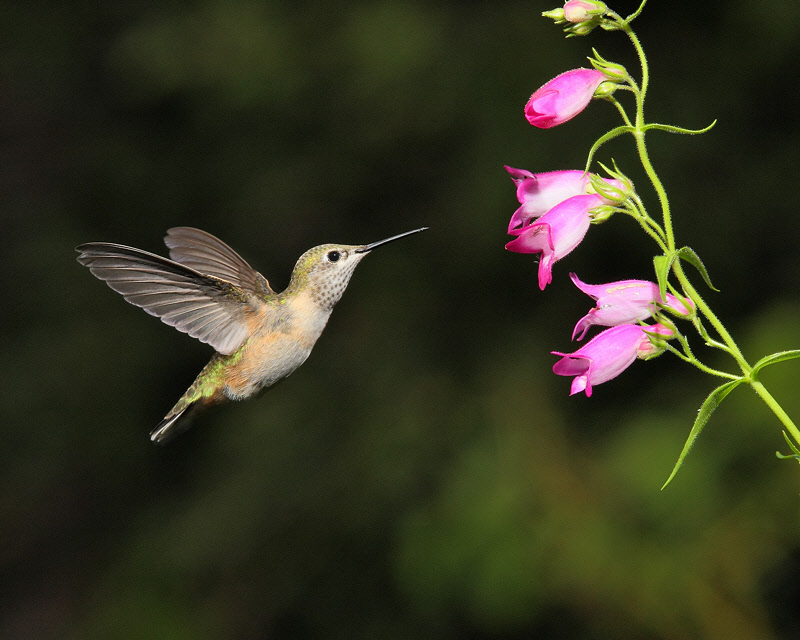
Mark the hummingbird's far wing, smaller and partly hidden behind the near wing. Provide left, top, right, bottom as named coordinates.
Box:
left=164, top=227, right=275, bottom=297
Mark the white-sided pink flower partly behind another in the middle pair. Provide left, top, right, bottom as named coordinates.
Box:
left=505, top=166, right=625, bottom=233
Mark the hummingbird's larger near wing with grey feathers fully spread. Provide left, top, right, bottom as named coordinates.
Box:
left=76, top=242, right=258, bottom=354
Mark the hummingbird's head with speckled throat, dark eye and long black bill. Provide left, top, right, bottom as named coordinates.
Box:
left=289, top=227, right=428, bottom=309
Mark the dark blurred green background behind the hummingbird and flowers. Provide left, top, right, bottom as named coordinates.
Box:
left=0, top=0, right=800, bottom=640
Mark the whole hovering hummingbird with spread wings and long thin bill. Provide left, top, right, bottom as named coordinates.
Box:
left=75, top=227, right=428, bottom=443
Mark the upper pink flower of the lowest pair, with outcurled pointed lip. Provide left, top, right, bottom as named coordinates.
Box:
left=569, top=273, right=692, bottom=340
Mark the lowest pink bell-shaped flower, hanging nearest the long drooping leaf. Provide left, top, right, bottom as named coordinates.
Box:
left=552, top=324, right=673, bottom=397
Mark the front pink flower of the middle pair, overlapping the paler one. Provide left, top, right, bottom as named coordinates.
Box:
left=506, top=194, right=603, bottom=290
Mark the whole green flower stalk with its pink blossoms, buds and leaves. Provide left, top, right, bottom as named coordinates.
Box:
left=506, top=0, right=800, bottom=486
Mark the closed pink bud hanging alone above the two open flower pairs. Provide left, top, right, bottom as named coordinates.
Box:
left=525, top=69, right=606, bottom=129
